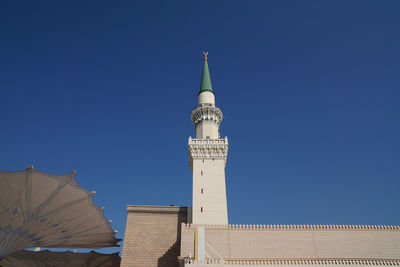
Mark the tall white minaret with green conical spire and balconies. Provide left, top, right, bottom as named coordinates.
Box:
left=189, top=52, right=228, bottom=224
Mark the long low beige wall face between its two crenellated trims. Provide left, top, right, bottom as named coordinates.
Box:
left=181, top=224, right=400, bottom=261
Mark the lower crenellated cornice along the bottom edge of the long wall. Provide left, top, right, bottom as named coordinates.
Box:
left=179, top=257, right=400, bottom=266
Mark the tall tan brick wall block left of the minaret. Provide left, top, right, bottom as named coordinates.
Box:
left=121, top=205, right=187, bottom=267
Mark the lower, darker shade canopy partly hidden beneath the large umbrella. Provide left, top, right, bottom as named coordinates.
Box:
left=0, top=250, right=121, bottom=267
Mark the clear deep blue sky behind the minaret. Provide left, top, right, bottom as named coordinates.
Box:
left=0, top=0, right=400, bottom=255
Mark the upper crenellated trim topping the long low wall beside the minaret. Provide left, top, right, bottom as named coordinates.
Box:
left=183, top=224, right=400, bottom=231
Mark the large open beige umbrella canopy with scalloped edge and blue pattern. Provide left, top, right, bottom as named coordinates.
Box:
left=0, top=167, right=120, bottom=259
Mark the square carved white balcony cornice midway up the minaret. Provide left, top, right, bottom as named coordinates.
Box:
left=189, top=137, right=228, bottom=162
